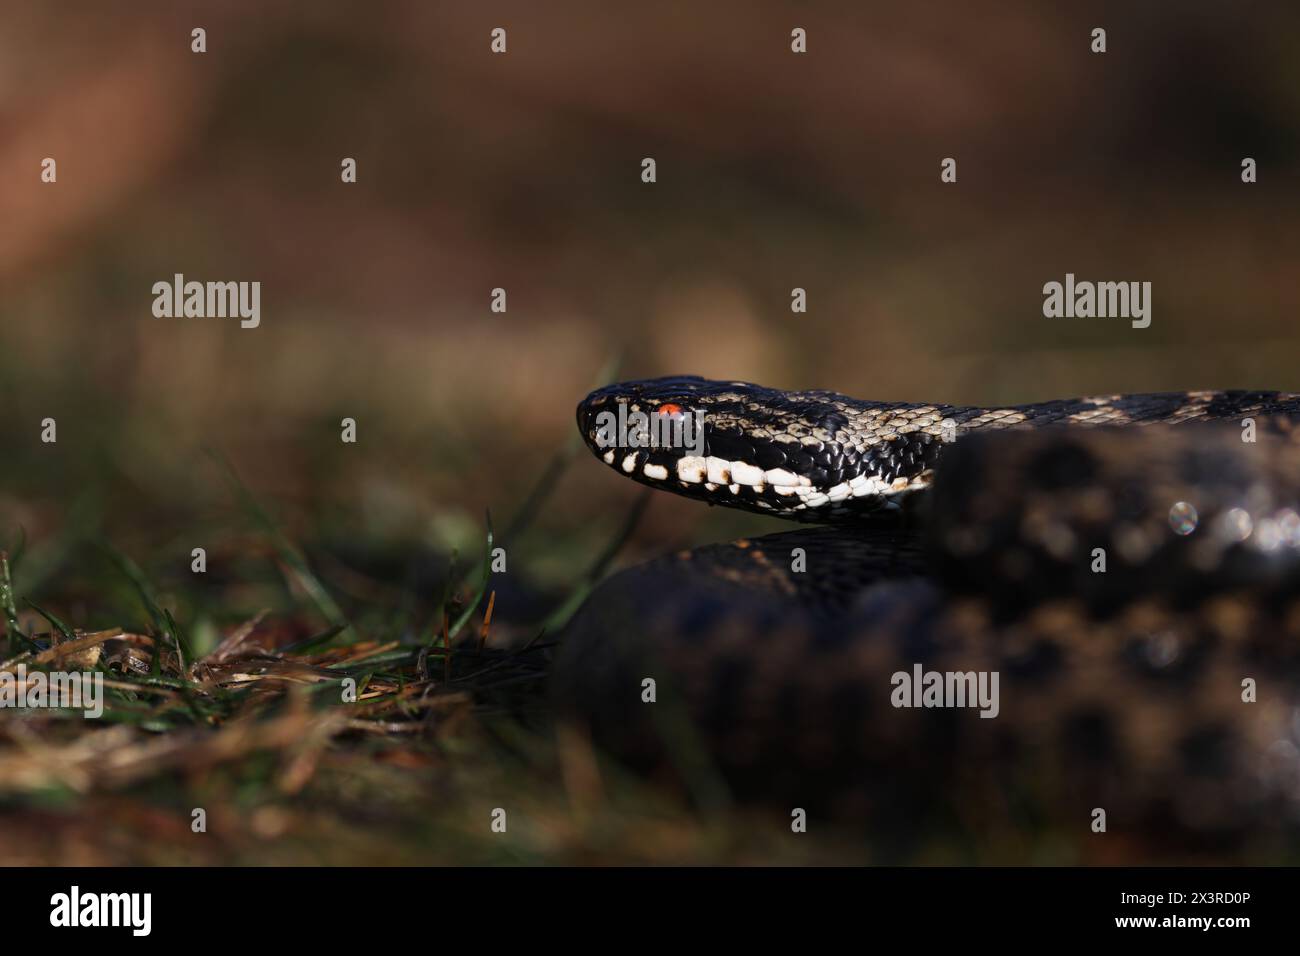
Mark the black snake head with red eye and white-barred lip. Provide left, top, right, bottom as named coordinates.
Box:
left=577, top=376, right=940, bottom=522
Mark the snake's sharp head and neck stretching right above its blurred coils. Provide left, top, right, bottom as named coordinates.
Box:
left=577, top=376, right=1297, bottom=522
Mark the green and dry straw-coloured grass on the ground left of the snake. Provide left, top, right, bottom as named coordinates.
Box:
left=0, top=426, right=883, bottom=865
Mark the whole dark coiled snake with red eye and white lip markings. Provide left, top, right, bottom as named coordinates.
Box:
left=551, top=376, right=1300, bottom=862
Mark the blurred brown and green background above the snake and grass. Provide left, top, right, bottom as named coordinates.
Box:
left=0, top=0, right=1300, bottom=863
